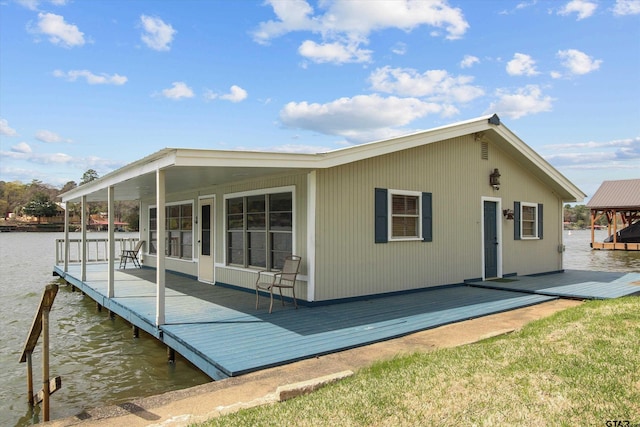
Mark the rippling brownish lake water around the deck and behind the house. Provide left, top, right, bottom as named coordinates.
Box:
left=0, top=230, right=640, bottom=426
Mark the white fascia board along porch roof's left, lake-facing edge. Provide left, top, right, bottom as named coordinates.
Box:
left=60, top=148, right=176, bottom=202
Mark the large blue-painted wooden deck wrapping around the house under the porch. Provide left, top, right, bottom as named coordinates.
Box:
left=54, top=264, right=640, bottom=379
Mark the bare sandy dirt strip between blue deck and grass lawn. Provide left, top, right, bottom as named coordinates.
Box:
left=46, top=299, right=581, bottom=427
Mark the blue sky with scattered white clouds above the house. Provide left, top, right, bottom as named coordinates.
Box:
left=0, top=0, right=640, bottom=201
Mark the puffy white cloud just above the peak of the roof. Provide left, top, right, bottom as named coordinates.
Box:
left=485, top=85, right=554, bottom=119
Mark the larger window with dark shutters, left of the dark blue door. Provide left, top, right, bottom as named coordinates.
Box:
left=375, top=188, right=433, bottom=243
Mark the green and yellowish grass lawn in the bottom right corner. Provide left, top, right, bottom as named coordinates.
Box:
left=195, top=297, right=640, bottom=427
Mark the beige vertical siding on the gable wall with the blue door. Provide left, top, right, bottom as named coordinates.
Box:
left=315, top=135, right=560, bottom=300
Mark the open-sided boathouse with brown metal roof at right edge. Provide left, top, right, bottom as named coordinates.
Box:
left=587, top=179, right=640, bottom=251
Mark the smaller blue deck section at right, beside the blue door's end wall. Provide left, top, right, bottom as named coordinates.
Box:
left=469, top=270, right=640, bottom=299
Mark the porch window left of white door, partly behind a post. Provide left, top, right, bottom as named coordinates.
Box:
left=149, top=203, right=193, bottom=259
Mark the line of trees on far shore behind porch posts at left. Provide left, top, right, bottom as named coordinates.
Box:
left=0, top=169, right=139, bottom=230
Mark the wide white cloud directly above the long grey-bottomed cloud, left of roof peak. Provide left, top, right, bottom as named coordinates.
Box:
left=369, top=66, right=484, bottom=103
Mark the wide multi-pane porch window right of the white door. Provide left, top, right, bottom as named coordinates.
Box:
left=226, top=192, right=293, bottom=269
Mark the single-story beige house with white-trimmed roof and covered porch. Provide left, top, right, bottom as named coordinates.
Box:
left=61, top=115, right=585, bottom=323
